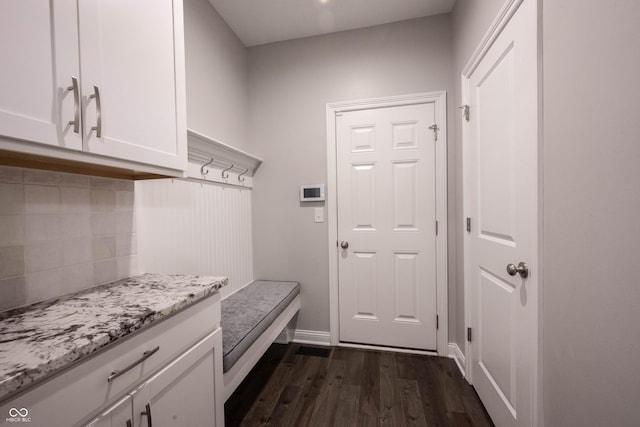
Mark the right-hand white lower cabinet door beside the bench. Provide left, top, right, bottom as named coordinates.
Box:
left=131, top=329, right=222, bottom=427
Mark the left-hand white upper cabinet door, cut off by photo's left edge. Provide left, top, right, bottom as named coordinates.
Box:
left=0, top=0, right=82, bottom=150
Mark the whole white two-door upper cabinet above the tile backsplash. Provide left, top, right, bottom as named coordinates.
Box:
left=0, top=0, right=187, bottom=171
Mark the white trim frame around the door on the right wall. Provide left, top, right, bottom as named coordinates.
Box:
left=460, top=0, right=544, bottom=426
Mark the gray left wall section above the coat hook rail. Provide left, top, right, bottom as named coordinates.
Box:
left=184, top=0, right=248, bottom=149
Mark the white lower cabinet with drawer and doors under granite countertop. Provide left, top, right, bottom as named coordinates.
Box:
left=0, top=293, right=224, bottom=427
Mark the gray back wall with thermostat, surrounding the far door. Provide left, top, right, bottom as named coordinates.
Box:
left=248, top=15, right=452, bottom=331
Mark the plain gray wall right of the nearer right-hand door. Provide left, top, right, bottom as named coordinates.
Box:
left=542, top=0, right=640, bottom=426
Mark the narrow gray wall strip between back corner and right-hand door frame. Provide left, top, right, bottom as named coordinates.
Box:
left=449, top=0, right=505, bottom=353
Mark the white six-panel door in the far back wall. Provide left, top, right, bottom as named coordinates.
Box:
left=336, top=103, right=437, bottom=350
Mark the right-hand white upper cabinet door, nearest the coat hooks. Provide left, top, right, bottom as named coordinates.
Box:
left=78, top=0, right=187, bottom=169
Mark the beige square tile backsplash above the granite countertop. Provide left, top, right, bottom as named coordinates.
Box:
left=0, top=166, right=138, bottom=311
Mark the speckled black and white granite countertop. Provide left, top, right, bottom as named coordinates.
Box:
left=0, top=274, right=228, bottom=401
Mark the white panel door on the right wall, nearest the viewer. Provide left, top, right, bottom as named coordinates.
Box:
left=464, top=0, right=538, bottom=426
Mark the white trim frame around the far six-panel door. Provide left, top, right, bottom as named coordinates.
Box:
left=326, top=91, right=449, bottom=356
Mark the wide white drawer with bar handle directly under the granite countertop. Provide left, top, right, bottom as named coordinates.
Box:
left=0, top=293, right=220, bottom=427
